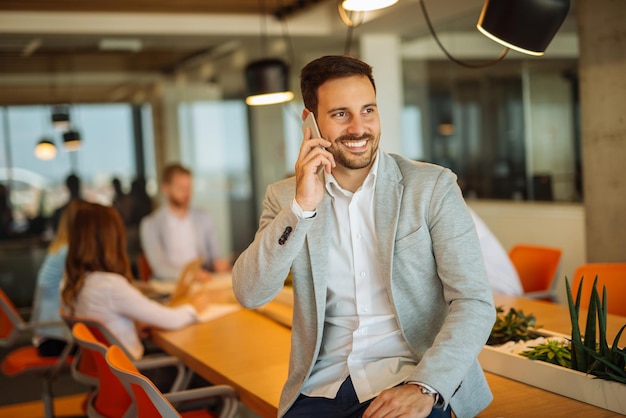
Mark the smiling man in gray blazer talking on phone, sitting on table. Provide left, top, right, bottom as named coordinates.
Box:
left=233, top=56, right=495, bottom=418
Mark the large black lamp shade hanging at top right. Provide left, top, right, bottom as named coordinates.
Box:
left=476, top=0, right=570, bottom=55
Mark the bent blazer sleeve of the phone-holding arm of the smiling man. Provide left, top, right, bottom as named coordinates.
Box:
left=233, top=179, right=319, bottom=308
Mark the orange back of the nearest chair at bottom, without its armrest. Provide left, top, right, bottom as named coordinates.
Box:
left=106, top=345, right=180, bottom=418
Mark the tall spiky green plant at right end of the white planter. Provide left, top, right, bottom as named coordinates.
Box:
left=565, top=276, right=626, bottom=383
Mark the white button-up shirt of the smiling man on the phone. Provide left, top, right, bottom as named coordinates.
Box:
left=302, top=153, right=416, bottom=402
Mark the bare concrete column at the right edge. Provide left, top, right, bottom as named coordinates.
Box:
left=576, top=0, right=626, bottom=262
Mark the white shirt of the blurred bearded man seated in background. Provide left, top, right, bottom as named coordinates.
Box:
left=164, top=210, right=200, bottom=272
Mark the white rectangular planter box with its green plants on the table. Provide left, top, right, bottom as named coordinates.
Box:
left=479, top=278, right=626, bottom=414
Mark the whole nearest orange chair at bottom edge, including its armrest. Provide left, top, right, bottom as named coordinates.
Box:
left=106, top=345, right=238, bottom=418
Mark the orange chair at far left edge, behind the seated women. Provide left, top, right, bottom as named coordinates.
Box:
left=0, top=289, right=73, bottom=417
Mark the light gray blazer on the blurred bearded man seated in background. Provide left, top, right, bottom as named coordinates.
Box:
left=139, top=206, right=218, bottom=279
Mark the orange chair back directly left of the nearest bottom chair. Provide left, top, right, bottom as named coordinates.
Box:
left=72, top=322, right=132, bottom=417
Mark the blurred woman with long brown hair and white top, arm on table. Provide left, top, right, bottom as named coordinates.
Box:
left=61, top=203, right=208, bottom=359
